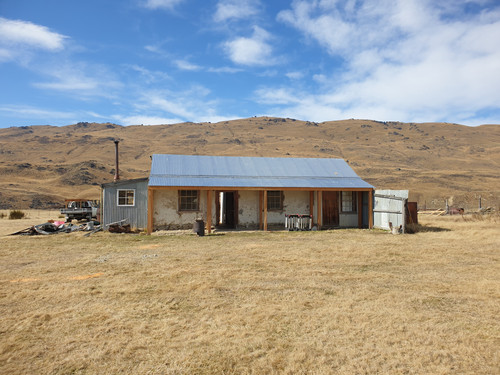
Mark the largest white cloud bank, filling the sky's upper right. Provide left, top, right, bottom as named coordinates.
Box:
left=272, top=0, right=500, bottom=122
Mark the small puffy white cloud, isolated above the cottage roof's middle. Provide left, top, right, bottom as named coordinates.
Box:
left=224, top=26, right=276, bottom=66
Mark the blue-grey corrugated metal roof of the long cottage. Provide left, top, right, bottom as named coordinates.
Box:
left=149, top=154, right=373, bottom=188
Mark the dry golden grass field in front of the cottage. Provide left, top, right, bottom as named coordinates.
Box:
left=0, top=214, right=500, bottom=374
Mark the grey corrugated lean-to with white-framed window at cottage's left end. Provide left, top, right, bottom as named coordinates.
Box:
left=101, top=177, right=148, bottom=229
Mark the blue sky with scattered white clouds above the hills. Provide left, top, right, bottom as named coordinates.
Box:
left=0, top=0, right=500, bottom=127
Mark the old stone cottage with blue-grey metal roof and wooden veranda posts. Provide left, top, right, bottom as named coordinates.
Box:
left=145, top=154, right=374, bottom=233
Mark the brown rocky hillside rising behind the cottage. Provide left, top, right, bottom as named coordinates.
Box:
left=0, top=117, right=500, bottom=209
